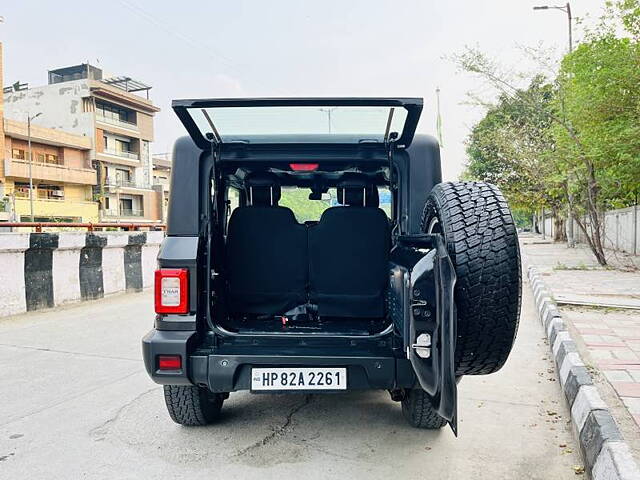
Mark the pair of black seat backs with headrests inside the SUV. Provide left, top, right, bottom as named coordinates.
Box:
left=226, top=172, right=390, bottom=318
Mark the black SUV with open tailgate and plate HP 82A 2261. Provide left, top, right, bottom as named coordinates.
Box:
left=142, top=98, right=521, bottom=432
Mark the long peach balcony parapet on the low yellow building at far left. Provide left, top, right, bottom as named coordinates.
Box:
left=4, top=158, right=98, bottom=185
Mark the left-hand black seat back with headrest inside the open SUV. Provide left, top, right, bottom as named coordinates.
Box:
left=226, top=172, right=308, bottom=315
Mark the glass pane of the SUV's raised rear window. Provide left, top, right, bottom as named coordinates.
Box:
left=187, top=106, right=407, bottom=143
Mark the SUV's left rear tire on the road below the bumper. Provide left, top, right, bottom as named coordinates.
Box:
left=164, top=385, right=225, bottom=426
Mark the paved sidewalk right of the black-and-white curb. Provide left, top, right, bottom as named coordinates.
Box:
left=521, top=234, right=640, bottom=436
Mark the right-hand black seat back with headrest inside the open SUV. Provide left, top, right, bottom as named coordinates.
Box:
left=309, top=173, right=391, bottom=318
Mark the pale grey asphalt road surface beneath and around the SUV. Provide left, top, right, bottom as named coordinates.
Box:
left=0, top=286, right=581, bottom=480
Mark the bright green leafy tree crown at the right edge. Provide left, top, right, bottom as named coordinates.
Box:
left=553, top=33, right=640, bottom=209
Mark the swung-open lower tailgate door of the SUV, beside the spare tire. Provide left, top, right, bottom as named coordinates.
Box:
left=399, top=235, right=458, bottom=435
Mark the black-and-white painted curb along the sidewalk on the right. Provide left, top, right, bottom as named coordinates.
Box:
left=527, top=267, right=640, bottom=480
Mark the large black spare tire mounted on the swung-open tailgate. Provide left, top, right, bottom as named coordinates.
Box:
left=421, top=182, right=522, bottom=376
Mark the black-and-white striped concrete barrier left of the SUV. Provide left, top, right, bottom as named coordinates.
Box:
left=0, top=231, right=164, bottom=316
